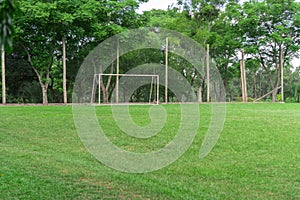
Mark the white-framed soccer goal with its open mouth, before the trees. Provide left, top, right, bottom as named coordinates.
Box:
left=91, top=73, right=159, bottom=104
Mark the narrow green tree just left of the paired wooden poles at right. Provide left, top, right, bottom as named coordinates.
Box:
left=207, top=2, right=243, bottom=99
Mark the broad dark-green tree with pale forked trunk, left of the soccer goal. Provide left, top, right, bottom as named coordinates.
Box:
left=17, top=0, right=149, bottom=104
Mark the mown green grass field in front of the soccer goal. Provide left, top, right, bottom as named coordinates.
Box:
left=0, top=104, right=300, bottom=199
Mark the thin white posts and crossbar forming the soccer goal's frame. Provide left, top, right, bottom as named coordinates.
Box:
left=91, top=73, right=159, bottom=104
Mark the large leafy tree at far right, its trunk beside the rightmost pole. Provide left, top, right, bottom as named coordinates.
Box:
left=238, top=0, right=300, bottom=101
